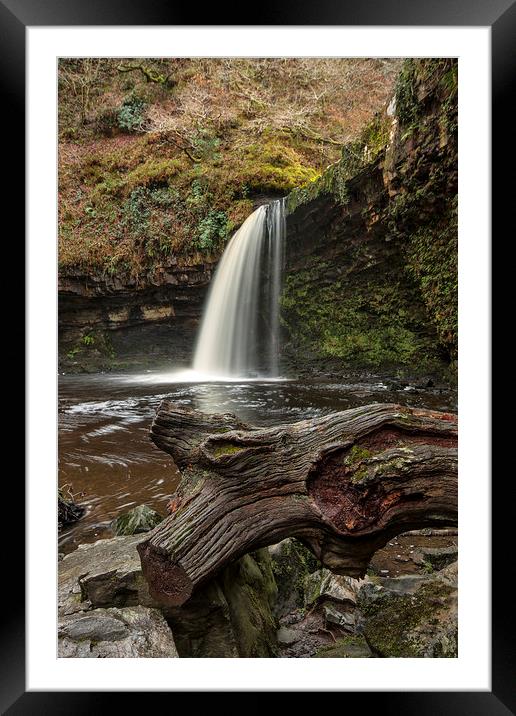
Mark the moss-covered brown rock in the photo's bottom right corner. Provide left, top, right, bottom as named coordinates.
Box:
left=358, top=565, right=457, bottom=658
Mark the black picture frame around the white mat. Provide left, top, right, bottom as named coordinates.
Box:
left=5, top=0, right=508, bottom=716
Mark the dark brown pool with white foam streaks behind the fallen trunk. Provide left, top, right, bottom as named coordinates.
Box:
left=59, top=373, right=457, bottom=552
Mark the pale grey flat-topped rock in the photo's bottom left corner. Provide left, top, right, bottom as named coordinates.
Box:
left=58, top=606, right=178, bottom=659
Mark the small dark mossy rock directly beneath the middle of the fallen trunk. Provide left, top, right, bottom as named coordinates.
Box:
left=269, top=538, right=321, bottom=618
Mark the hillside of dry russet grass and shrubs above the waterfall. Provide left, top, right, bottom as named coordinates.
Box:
left=59, top=59, right=400, bottom=278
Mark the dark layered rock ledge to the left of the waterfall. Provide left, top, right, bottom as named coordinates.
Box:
left=58, top=259, right=214, bottom=372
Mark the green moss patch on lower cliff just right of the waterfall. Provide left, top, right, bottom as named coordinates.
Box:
left=281, top=256, right=444, bottom=368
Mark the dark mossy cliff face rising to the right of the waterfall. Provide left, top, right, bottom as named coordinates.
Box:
left=282, top=60, right=457, bottom=375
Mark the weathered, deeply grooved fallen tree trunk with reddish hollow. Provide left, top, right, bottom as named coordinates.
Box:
left=138, top=402, right=457, bottom=605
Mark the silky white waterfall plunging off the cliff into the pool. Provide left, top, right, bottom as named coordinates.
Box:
left=193, top=199, right=285, bottom=379
